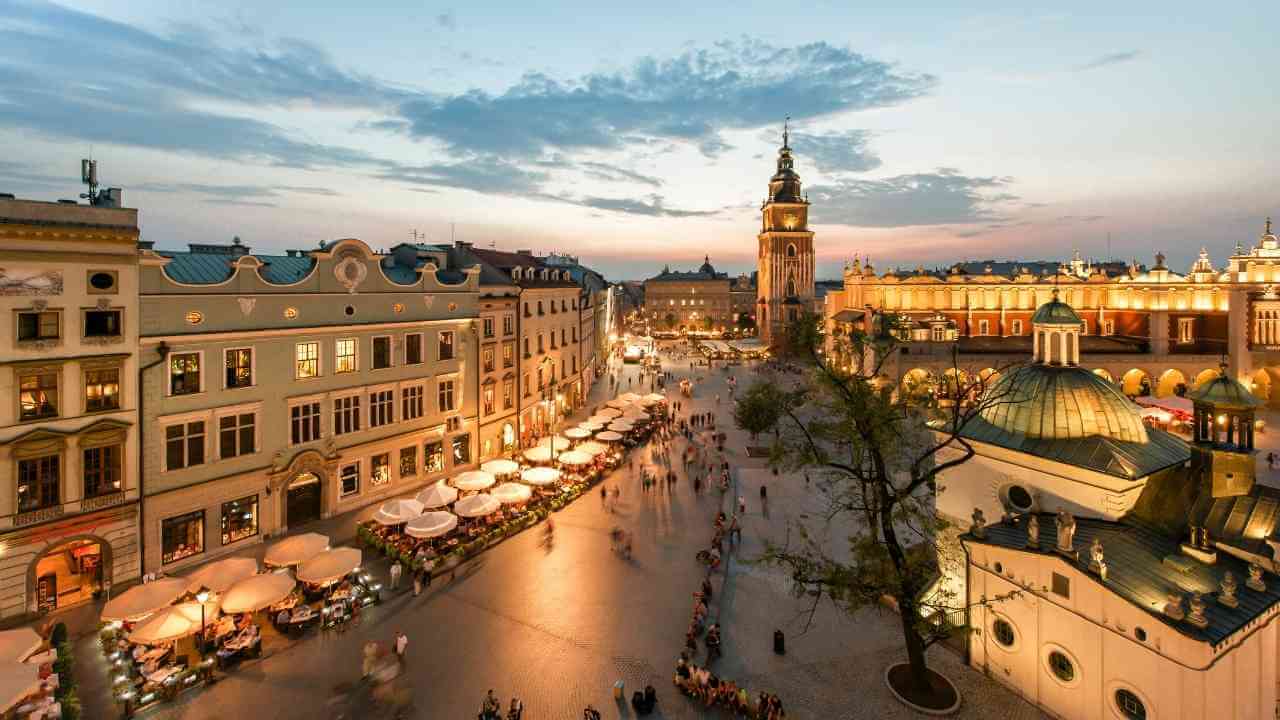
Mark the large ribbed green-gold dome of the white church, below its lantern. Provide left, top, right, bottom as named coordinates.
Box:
left=980, top=363, right=1148, bottom=443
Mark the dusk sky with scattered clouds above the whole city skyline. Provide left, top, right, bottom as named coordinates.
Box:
left=0, top=0, right=1280, bottom=281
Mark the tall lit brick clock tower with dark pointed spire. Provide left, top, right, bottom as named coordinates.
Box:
left=755, top=120, right=814, bottom=347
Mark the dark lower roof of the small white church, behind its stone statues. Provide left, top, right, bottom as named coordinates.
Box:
left=961, top=512, right=1280, bottom=644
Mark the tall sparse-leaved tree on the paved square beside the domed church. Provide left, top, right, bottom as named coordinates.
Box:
left=735, top=315, right=1021, bottom=707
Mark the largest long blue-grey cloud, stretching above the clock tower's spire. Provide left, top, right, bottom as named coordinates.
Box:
left=398, top=40, right=936, bottom=158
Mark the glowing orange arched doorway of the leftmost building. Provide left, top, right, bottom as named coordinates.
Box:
left=27, top=536, right=111, bottom=612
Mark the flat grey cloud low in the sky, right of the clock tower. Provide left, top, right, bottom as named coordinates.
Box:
left=809, top=168, right=1016, bottom=228
